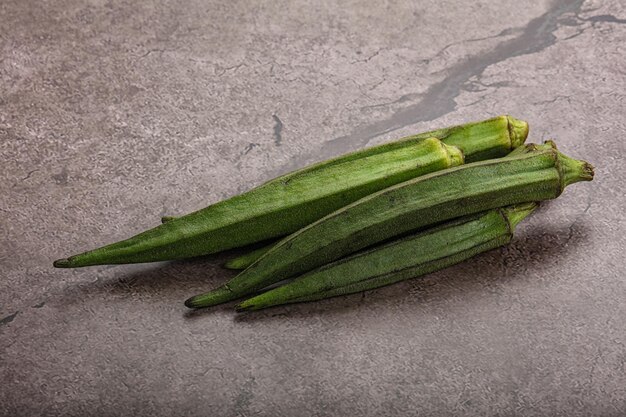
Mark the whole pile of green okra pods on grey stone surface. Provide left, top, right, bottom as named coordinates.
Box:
left=54, top=116, right=593, bottom=311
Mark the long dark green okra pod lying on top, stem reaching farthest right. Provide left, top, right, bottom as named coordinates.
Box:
left=185, top=141, right=593, bottom=308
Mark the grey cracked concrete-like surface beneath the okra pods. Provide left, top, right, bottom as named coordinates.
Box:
left=0, top=0, right=626, bottom=416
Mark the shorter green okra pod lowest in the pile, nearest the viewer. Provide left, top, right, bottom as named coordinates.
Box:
left=236, top=203, right=537, bottom=311
